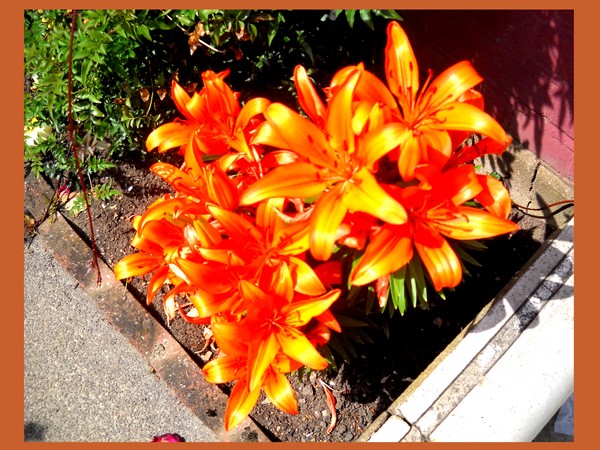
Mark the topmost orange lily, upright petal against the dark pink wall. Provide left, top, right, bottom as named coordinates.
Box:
left=385, top=22, right=510, bottom=181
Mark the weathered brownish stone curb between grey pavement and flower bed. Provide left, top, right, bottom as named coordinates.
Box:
left=24, top=172, right=270, bottom=442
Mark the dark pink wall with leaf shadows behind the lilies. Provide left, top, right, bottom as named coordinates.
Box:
left=400, top=10, right=574, bottom=181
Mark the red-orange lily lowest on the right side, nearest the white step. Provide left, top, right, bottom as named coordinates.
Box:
left=350, top=165, right=519, bottom=291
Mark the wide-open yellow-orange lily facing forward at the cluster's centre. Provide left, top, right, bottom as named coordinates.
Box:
left=240, top=70, right=406, bottom=260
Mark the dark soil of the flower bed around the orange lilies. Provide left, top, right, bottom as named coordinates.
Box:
left=66, top=153, right=553, bottom=442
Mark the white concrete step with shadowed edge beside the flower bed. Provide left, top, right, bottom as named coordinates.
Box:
left=359, top=218, right=575, bottom=442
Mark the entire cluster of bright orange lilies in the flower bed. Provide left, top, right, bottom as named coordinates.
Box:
left=114, top=22, right=517, bottom=429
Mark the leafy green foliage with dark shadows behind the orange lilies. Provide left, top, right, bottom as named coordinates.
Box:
left=24, top=9, right=400, bottom=197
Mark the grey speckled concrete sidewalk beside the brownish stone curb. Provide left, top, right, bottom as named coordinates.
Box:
left=24, top=237, right=217, bottom=442
